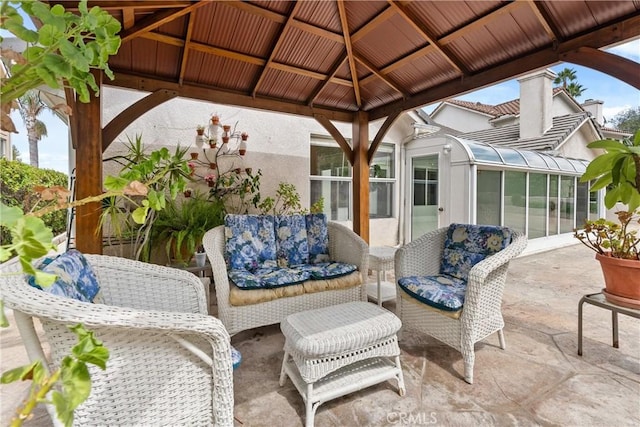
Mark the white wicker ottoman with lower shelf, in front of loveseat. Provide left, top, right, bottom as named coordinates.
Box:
left=280, top=301, right=405, bottom=427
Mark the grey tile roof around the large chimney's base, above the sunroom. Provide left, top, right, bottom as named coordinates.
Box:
left=460, top=111, right=599, bottom=151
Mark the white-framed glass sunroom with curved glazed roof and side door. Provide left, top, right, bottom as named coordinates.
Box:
left=403, top=135, right=603, bottom=247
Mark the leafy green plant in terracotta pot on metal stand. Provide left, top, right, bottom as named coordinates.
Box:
left=574, top=130, right=640, bottom=308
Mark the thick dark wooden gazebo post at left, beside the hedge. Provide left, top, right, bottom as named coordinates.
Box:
left=71, top=71, right=102, bottom=254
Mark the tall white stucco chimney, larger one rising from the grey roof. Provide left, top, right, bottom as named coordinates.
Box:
left=518, top=69, right=556, bottom=139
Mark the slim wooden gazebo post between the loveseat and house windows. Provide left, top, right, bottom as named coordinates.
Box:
left=353, top=111, right=369, bottom=243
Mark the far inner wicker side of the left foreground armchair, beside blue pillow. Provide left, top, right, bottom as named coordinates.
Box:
left=85, top=254, right=208, bottom=314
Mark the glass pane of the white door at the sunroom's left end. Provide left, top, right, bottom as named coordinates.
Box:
left=410, top=154, right=439, bottom=240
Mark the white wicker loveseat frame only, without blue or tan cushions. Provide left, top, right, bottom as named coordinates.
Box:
left=202, top=221, right=369, bottom=336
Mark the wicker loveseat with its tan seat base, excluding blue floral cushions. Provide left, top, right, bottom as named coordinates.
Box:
left=203, top=215, right=369, bottom=335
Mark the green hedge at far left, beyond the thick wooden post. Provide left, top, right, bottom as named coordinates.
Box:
left=0, top=158, right=68, bottom=245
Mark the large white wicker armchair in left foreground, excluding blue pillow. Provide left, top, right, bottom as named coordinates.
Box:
left=0, top=255, right=233, bottom=426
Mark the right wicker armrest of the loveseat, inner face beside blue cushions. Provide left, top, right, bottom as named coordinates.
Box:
left=327, top=221, right=369, bottom=277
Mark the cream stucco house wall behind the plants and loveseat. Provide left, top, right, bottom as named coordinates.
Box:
left=102, top=86, right=408, bottom=246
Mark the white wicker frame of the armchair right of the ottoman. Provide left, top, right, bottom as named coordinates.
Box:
left=395, top=227, right=527, bottom=384
